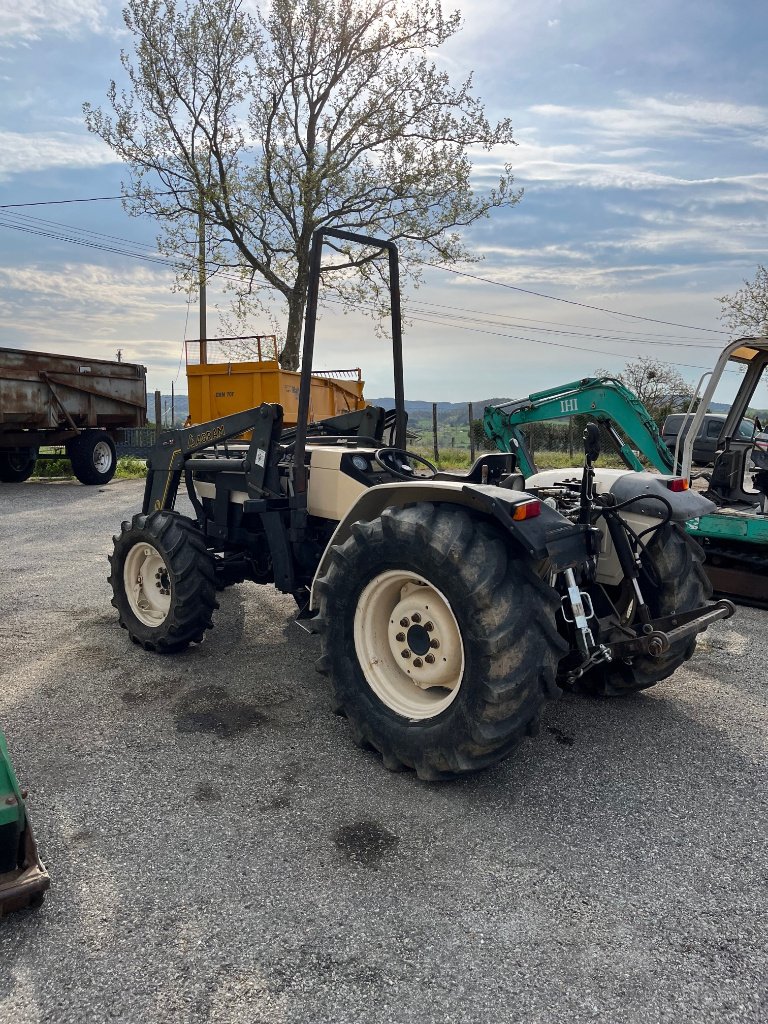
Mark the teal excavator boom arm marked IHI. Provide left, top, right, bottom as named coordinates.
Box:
left=482, top=377, right=675, bottom=476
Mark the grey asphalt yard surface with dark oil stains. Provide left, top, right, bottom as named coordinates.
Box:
left=0, top=481, right=768, bottom=1024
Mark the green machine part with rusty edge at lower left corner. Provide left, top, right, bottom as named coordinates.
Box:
left=0, top=732, right=50, bottom=918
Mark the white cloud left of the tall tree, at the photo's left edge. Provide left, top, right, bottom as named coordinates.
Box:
left=0, top=131, right=120, bottom=179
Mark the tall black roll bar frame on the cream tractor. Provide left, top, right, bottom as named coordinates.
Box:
left=294, top=227, right=406, bottom=494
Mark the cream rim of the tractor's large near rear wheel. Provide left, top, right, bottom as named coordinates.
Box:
left=354, top=569, right=464, bottom=720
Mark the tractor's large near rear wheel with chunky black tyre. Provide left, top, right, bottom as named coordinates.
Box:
left=315, top=503, right=566, bottom=781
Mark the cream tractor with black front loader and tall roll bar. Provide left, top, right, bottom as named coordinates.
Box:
left=110, top=228, right=734, bottom=781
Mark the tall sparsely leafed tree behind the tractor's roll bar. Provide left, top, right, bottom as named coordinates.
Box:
left=84, top=0, right=520, bottom=369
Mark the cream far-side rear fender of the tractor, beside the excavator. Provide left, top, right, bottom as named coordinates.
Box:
left=525, top=467, right=717, bottom=522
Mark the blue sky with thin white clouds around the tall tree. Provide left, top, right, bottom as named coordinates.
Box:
left=0, top=0, right=768, bottom=404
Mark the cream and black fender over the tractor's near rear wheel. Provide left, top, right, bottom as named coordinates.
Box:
left=310, top=479, right=590, bottom=608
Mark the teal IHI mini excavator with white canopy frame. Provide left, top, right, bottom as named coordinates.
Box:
left=483, top=337, right=768, bottom=607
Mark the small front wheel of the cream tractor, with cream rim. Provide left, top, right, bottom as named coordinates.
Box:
left=110, top=511, right=218, bottom=654
